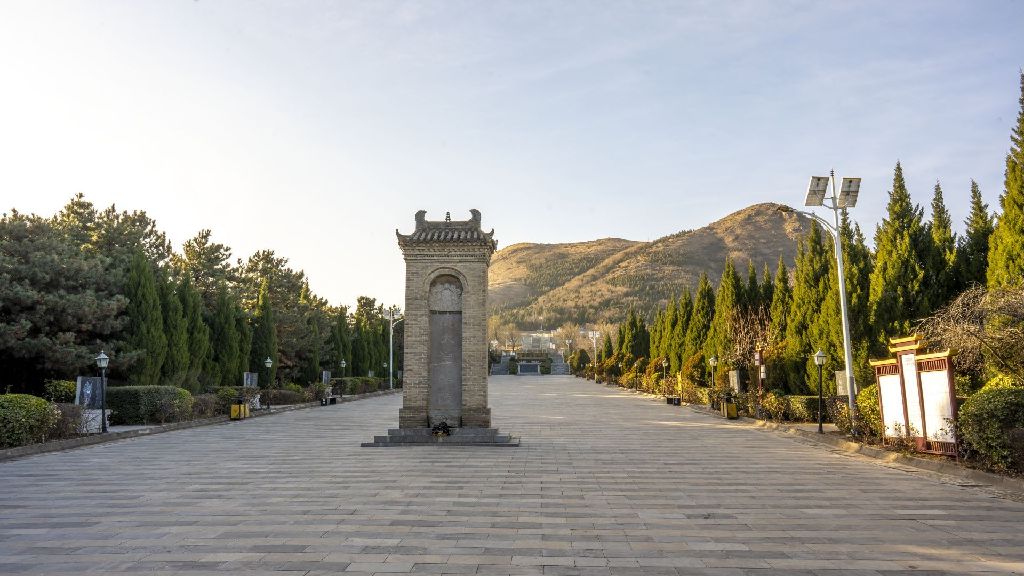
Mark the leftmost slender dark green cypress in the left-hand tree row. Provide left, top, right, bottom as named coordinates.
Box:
left=125, top=251, right=167, bottom=385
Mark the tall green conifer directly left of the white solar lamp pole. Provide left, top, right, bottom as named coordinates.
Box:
left=785, top=225, right=835, bottom=393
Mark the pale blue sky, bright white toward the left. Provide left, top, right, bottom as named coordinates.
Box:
left=0, top=0, right=1024, bottom=305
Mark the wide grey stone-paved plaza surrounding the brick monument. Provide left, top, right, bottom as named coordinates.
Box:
left=0, top=376, right=1024, bottom=576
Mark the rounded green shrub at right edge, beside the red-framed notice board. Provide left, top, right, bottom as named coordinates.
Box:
left=957, top=386, right=1024, bottom=470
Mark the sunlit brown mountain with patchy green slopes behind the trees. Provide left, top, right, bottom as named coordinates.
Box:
left=487, top=203, right=810, bottom=328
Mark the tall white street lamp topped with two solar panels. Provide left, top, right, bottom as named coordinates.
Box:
left=779, top=170, right=860, bottom=429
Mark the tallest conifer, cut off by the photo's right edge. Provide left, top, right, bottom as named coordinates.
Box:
left=987, top=73, right=1024, bottom=288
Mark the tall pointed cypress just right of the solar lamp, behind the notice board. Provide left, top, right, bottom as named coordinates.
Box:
left=868, top=162, right=930, bottom=356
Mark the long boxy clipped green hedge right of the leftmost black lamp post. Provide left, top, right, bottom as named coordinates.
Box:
left=106, top=386, right=193, bottom=424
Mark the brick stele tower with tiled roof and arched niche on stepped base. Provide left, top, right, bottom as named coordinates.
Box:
left=364, top=210, right=518, bottom=446
